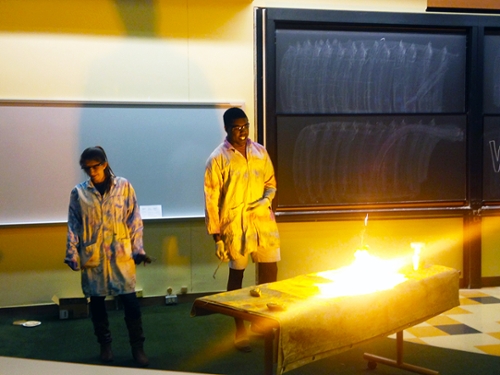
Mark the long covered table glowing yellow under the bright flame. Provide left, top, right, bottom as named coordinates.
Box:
left=191, top=266, right=459, bottom=375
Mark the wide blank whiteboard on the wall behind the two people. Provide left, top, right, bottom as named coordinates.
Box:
left=0, top=101, right=241, bottom=225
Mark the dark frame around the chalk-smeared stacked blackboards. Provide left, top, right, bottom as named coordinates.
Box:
left=256, top=8, right=500, bottom=220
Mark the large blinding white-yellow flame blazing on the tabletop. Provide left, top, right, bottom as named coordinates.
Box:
left=316, top=250, right=407, bottom=298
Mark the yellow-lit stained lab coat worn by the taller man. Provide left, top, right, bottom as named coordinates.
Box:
left=204, top=139, right=280, bottom=262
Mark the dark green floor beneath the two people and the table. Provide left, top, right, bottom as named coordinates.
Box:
left=0, top=302, right=500, bottom=375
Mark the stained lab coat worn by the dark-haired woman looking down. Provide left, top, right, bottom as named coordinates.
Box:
left=65, top=176, right=145, bottom=297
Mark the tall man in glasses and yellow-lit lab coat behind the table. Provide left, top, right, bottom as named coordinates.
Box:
left=204, top=108, right=280, bottom=352
